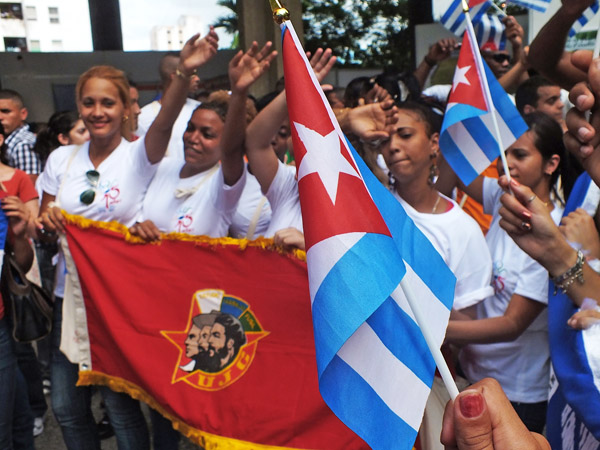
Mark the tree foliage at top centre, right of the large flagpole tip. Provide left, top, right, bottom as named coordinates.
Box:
left=302, top=0, right=412, bottom=68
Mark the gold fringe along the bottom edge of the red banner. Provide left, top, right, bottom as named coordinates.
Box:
left=77, top=370, right=308, bottom=450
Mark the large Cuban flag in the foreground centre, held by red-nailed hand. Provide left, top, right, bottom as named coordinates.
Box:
left=282, top=22, right=455, bottom=450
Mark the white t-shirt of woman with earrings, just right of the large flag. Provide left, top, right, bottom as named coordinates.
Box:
left=394, top=190, right=494, bottom=310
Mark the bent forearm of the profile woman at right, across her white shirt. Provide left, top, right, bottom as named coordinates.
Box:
left=446, top=294, right=546, bottom=345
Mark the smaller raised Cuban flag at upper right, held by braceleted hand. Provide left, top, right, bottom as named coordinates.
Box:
left=440, top=31, right=527, bottom=186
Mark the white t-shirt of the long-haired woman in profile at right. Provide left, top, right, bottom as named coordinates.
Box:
left=460, top=178, right=562, bottom=403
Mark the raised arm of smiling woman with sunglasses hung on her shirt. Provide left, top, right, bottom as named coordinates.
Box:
left=144, top=27, right=219, bottom=164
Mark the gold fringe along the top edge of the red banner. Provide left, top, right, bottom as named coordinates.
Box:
left=62, top=210, right=306, bottom=261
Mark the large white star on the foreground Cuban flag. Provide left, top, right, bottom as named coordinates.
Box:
left=294, top=122, right=360, bottom=205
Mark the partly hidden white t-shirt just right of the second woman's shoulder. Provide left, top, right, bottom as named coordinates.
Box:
left=229, top=170, right=271, bottom=239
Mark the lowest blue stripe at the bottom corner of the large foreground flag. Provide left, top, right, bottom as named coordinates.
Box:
left=319, top=356, right=417, bottom=450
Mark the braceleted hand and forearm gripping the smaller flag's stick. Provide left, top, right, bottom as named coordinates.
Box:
left=500, top=176, right=600, bottom=306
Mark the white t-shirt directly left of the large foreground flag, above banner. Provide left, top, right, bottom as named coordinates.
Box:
left=265, top=161, right=304, bottom=237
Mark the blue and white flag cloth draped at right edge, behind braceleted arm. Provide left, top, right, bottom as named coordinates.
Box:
left=547, top=172, right=600, bottom=450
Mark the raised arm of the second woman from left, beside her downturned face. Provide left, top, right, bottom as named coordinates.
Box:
left=221, top=42, right=277, bottom=186
